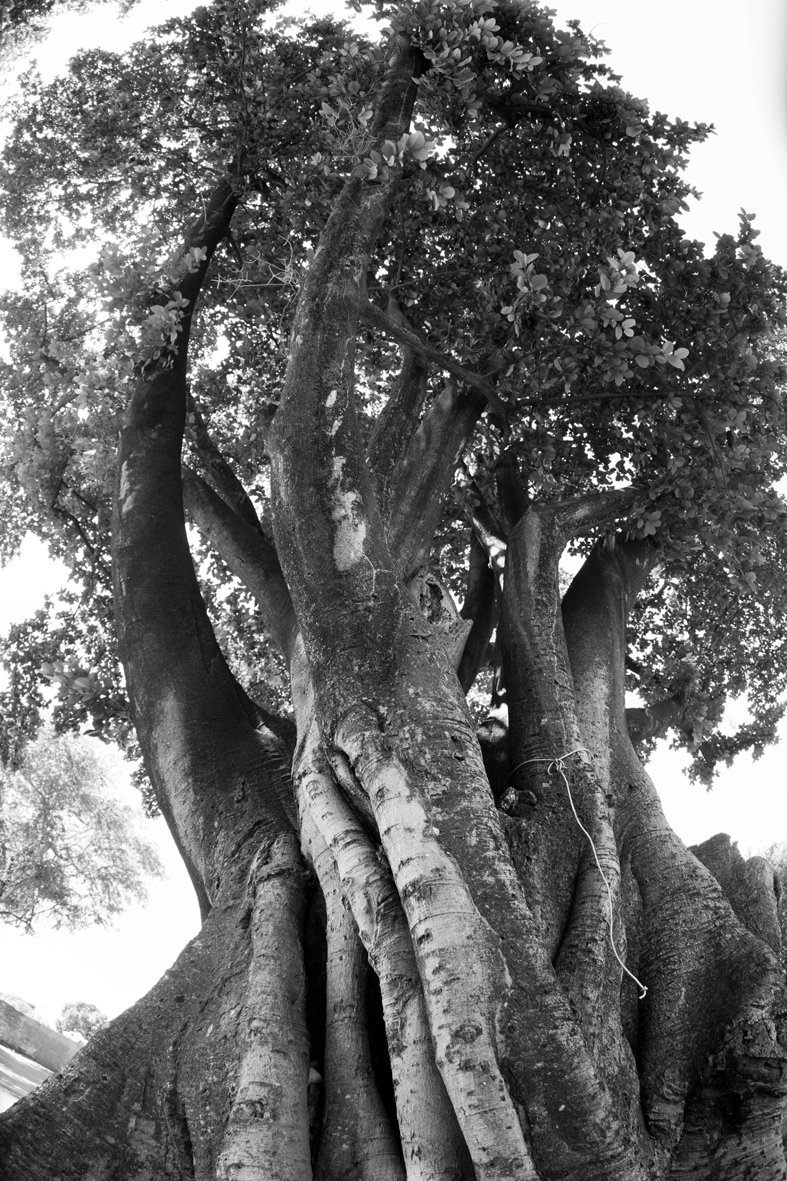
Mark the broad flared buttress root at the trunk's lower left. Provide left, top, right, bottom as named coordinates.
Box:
left=0, top=849, right=308, bottom=1181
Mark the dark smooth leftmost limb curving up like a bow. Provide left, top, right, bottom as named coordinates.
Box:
left=112, top=181, right=292, bottom=913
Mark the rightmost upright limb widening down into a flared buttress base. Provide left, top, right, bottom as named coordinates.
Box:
left=564, top=542, right=786, bottom=1179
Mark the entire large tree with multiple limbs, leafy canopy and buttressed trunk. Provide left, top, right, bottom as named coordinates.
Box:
left=0, top=0, right=787, bottom=1181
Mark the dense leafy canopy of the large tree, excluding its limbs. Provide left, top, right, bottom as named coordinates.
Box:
left=0, top=0, right=787, bottom=762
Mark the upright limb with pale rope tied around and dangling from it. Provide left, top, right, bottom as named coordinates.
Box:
left=501, top=497, right=636, bottom=1105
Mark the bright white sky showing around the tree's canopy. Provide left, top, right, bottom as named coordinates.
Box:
left=0, top=0, right=787, bottom=1023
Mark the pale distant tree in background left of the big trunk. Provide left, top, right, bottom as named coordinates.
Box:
left=0, top=730, right=162, bottom=931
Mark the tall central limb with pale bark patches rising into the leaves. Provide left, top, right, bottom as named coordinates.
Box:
left=271, top=37, right=423, bottom=691
